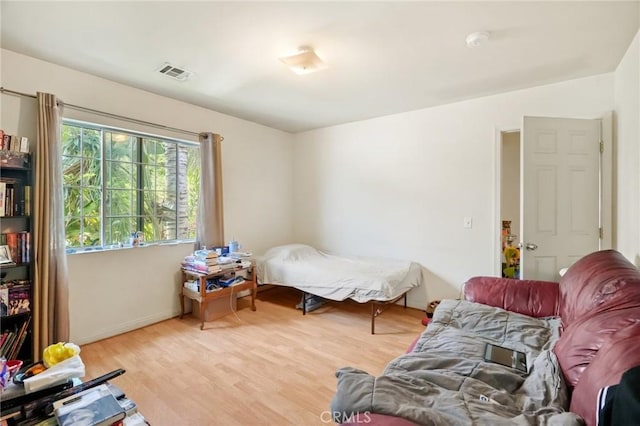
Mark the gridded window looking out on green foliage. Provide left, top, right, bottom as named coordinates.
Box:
left=62, top=120, right=200, bottom=248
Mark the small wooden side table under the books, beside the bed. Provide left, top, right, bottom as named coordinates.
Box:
left=179, top=265, right=258, bottom=330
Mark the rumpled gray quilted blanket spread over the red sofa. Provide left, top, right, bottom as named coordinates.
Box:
left=331, top=300, right=582, bottom=425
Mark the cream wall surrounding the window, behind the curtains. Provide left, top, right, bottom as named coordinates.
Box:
left=0, top=50, right=293, bottom=344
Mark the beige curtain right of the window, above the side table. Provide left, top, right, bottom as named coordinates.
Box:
left=195, top=133, right=224, bottom=250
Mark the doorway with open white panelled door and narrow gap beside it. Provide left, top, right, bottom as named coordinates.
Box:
left=495, top=113, right=613, bottom=281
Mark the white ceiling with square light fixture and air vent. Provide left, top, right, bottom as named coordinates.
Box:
left=1, top=0, right=640, bottom=132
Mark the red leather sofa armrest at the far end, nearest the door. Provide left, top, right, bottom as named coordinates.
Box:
left=463, top=277, right=560, bottom=318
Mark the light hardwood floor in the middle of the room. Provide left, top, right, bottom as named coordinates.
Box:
left=81, top=287, right=424, bottom=426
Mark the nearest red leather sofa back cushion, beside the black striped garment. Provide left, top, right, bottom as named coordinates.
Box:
left=570, top=321, right=640, bottom=424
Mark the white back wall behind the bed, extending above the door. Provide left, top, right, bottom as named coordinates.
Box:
left=294, top=74, right=614, bottom=307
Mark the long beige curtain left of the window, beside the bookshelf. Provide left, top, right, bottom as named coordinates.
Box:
left=32, top=92, right=69, bottom=360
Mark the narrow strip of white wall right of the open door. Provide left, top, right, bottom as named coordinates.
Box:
left=614, top=32, right=640, bottom=266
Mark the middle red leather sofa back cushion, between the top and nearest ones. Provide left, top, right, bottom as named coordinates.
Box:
left=553, top=306, right=640, bottom=390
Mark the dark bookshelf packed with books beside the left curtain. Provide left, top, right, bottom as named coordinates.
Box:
left=0, top=150, right=34, bottom=363
